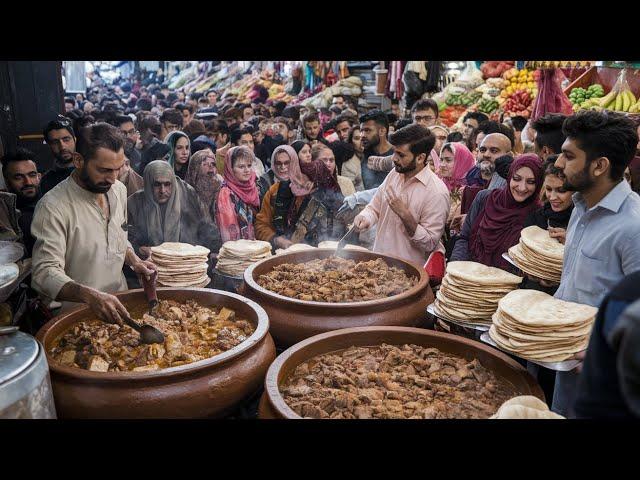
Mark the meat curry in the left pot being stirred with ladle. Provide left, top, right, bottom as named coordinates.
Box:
left=49, top=300, right=255, bottom=372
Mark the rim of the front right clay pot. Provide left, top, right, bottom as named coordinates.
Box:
left=264, top=326, right=544, bottom=420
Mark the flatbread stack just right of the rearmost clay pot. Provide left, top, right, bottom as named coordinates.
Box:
left=433, top=262, right=522, bottom=325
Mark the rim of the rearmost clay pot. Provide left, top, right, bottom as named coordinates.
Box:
left=244, top=248, right=429, bottom=309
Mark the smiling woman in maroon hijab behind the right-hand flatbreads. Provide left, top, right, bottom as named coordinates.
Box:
left=450, top=154, right=543, bottom=271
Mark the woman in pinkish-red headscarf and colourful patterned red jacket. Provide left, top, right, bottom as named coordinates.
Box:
left=213, top=146, right=260, bottom=243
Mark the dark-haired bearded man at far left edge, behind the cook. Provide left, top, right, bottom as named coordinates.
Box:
left=2, top=148, right=40, bottom=257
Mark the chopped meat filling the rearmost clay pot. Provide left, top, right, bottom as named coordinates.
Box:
left=258, top=257, right=418, bottom=303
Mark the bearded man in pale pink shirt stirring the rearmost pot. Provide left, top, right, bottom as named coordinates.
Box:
left=354, top=124, right=450, bottom=267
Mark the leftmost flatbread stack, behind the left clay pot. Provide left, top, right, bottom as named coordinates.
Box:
left=149, top=242, right=211, bottom=288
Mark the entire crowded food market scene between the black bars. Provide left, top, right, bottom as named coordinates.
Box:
left=0, top=60, right=640, bottom=423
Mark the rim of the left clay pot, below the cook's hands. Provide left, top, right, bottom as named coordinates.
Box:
left=36, top=287, right=269, bottom=381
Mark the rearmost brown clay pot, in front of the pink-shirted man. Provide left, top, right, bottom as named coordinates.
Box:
left=243, top=249, right=434, bottom=348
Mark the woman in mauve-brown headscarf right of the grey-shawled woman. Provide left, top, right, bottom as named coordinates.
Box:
left=185, top=148, right=224, bottom=221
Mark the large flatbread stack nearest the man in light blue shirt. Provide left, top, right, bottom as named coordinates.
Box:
left=489, top=290, right=598, bottom=362
